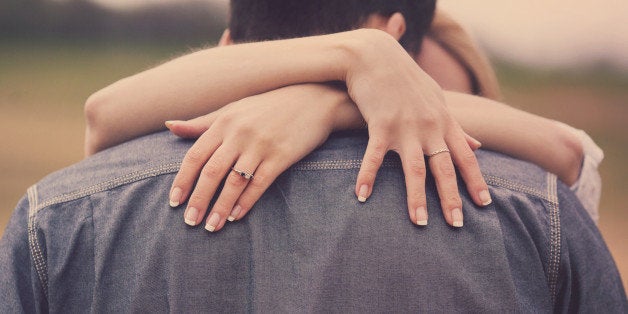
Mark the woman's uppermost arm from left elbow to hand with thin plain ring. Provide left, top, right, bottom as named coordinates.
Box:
left=86, top=30, right=490, bottom=226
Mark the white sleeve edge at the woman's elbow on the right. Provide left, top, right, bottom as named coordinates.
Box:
left=556, top=121, right=604, bottom=223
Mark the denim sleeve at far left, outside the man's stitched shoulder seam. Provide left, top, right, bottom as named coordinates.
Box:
left=0, top=198, right=42, bottom=313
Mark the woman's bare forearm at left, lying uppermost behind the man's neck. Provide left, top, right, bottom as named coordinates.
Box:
left=85, top=30, right=392, bottom=155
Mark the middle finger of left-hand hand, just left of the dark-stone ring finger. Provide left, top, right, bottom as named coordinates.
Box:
left=184, top=146, right=237, bottom=226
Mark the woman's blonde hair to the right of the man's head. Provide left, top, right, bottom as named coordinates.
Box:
left=427, top=10, right=501, bottom=100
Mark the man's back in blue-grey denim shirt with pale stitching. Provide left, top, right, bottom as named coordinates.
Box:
left=0, top=133, right=626, bottom=312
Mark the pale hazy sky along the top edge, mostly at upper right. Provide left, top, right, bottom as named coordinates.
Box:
left=94, top=0, right=628, bottom=71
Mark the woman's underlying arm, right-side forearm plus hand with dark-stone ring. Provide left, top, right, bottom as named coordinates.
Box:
left=167, top=84, right=582, bottom=232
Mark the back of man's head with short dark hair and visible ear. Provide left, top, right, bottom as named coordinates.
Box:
left=229, top=0, right=436, bottom=53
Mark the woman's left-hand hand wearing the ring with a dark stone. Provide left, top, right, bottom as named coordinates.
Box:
left=168, top=85, right=360, bottom=232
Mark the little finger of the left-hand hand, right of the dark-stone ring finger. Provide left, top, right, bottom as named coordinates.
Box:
left=230, top=161, right=285, bottom=220
